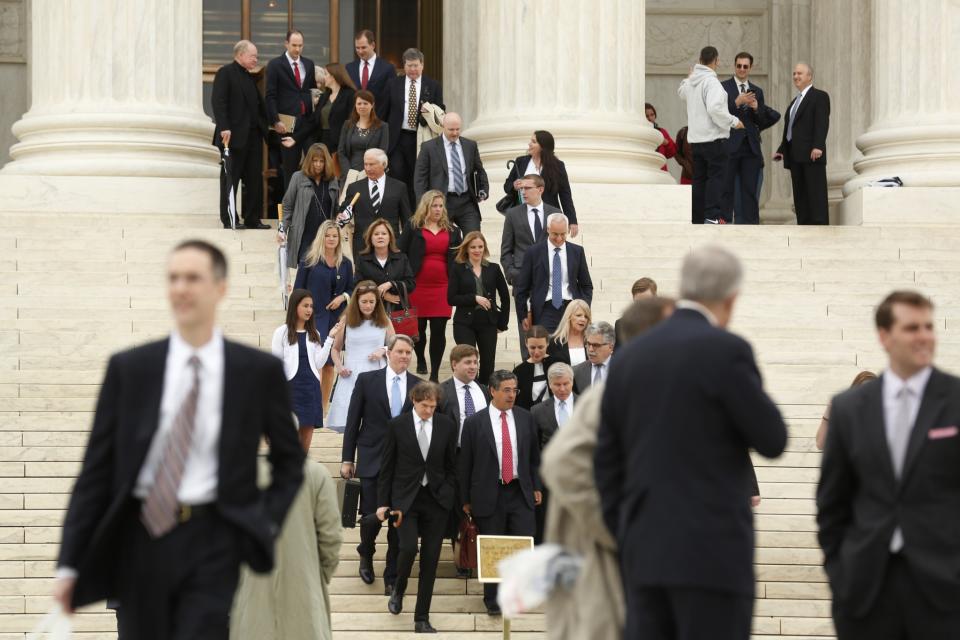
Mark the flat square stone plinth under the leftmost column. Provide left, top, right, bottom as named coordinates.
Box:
left=0, top=174, right=220, bottom=219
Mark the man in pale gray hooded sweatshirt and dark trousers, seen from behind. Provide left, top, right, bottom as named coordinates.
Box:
left=677, top=47, right=743, bottom=224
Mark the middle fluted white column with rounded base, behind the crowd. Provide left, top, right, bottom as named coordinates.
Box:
left=466, top=0, right=673, bottom=184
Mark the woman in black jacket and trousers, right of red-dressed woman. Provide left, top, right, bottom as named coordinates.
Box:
left=447, top=231, right=510, bottom=382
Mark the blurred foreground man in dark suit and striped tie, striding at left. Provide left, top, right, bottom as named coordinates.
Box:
left=55, top=240, right=304, bottom=640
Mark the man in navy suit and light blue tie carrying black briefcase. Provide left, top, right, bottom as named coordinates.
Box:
left=340, top=335, right=423, bottom=595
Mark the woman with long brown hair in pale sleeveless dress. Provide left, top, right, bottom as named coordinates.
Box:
left=327, top=280, right=394, bottom=433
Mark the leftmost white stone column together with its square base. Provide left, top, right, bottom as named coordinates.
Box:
left=0, top=0, right=219, bottom=212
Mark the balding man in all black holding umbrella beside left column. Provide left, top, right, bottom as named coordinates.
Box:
left=211, top=40, right=270, bottom=229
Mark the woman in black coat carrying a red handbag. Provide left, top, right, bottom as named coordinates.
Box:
left=356, top=218, right=417, bottom=313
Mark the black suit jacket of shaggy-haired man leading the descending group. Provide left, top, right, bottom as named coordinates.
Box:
left=377, top=412, right=458, bottom=513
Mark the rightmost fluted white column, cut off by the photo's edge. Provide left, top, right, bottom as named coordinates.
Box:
left=843, top=0, right=960, bottom=195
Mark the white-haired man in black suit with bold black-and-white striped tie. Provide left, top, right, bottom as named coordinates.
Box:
left=343, top=149, right=410, bottom=262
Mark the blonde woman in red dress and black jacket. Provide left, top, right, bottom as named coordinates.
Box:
left=400, top=191, right=463, bottom=382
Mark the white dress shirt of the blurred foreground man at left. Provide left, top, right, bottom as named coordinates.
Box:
left=133, top=329, right=224, bottom=504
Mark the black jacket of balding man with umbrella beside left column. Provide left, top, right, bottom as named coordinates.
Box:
left=210, top=61, right=269, bottom=149
